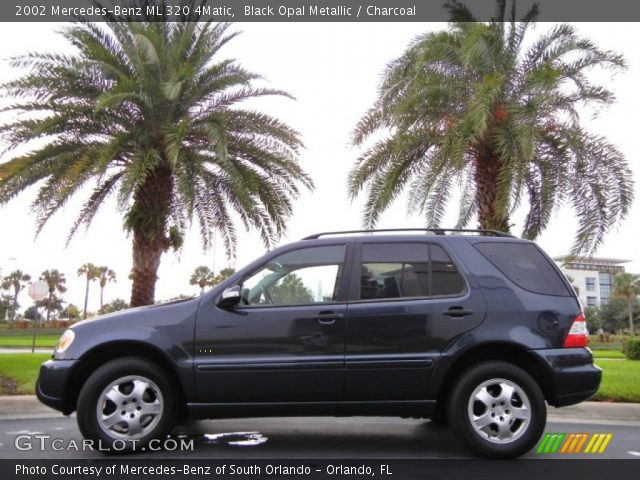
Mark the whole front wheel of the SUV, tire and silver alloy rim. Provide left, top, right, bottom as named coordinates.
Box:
left=77, top=357, right=179, bottom=453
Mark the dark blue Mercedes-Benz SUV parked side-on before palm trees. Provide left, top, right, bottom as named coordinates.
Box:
left=37, top=229, right=601, bottom=458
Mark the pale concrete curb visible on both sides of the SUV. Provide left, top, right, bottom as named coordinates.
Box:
left=0, top=395, right=640, bottom=425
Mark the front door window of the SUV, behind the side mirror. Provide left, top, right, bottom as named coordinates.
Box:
left=241, top=245, right=346, bottom=305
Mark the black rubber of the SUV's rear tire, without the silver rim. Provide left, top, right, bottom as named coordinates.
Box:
left=447, top=362, right=547, bottom=458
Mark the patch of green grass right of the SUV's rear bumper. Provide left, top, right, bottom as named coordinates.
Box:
left=594, top=360, right=640, bottom=403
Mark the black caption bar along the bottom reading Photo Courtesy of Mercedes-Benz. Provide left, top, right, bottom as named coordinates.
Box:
left=0, top=457, right=639, bottom=480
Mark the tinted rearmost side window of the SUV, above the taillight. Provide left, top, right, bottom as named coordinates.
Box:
left=474, top=242, right=571, bottom=296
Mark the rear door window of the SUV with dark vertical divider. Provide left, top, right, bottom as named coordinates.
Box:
left=360, top=243, right=465, bottom=300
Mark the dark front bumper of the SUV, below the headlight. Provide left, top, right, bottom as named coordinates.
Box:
left=36, top=360, right=77, bottom=415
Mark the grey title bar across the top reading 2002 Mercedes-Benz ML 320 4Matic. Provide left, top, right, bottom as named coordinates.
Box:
left=0, top=0, right=640, bottom=22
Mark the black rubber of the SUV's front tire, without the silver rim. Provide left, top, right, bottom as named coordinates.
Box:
left=77, top=357, right=177, bottom=454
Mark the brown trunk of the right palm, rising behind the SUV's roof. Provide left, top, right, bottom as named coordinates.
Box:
left=475, top=148, right=509, bottom=232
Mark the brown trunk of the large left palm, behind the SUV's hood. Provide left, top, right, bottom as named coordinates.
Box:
left=129, top=168, right=173, bottom=307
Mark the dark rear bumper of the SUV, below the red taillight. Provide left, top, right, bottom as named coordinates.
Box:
left=529, top=348, right=602, bottom=407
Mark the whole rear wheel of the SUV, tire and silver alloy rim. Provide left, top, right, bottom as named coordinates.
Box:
left=447, top=361, right=547, bottom=458
